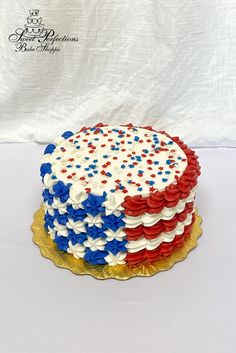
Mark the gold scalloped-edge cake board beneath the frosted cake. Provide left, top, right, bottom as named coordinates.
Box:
left=32, top=205, right=202, bottom=280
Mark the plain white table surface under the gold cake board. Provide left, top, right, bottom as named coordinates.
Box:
left=0, top=144, right=236, bottom=353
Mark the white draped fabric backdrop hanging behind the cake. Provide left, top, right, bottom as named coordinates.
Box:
left=0, top=0, right=236, bottom=146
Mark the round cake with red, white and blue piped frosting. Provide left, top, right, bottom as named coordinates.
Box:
left=40, top=123, right=200, bottom=266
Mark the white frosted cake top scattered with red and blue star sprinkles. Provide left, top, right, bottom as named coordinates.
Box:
left=43, top=126, right=187, bottom=197
